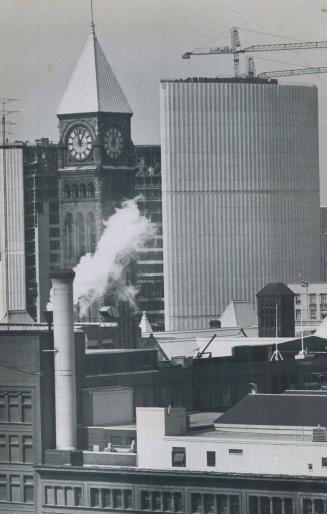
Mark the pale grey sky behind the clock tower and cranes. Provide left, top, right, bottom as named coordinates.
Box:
left=0, top=0, right=327, bottom=200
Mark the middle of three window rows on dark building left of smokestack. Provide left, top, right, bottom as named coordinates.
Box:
left=0, top=434, right=33, bottom=463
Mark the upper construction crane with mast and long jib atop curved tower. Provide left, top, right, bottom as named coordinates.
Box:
left=182, top=27, right=327, bottom=77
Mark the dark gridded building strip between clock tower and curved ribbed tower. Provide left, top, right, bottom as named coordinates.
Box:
left=135, top=145, right=164, bottom=330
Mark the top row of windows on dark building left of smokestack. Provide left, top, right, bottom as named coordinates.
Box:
left=0, top=392, right=32, bottom=423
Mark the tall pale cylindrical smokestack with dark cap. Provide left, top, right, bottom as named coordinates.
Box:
left=51, top=269, right=77, bottom=450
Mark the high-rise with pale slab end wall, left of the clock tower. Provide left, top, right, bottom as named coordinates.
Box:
left=0, top=139, right=60, bottom=323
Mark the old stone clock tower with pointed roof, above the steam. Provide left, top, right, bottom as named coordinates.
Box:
left=57, top=22, right=135, bottom=267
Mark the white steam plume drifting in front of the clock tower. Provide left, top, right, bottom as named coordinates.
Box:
left=74, top=198, right=156, bottom=316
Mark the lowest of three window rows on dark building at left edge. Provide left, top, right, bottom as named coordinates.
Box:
left=0, top=474, right=34, bottom=503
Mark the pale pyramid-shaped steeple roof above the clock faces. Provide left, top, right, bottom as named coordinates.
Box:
left=57, top=26, right=133, bottom=115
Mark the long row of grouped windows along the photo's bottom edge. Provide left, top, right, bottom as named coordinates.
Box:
left=39, top=484, right=327, bottom=514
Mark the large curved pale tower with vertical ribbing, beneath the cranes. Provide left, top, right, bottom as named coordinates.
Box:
left=160, top=78, right=321, bottom=330
